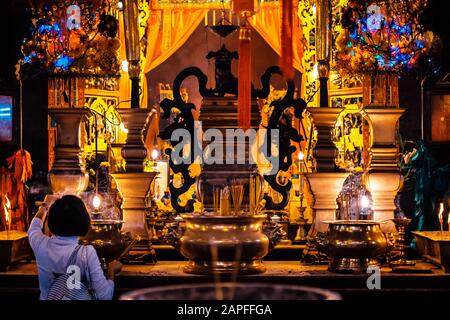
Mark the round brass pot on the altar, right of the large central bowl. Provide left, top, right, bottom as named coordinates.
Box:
left=316, top=220, right=388, bottom=273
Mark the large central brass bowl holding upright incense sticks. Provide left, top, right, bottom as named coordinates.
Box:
left=166, top=215, right=270, bottom=275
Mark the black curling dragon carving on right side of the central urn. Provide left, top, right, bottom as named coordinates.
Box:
left=254, top=66, right=306, bottom=210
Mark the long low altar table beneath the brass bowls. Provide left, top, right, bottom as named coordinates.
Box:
left=0, top=260, right=450, bottom=300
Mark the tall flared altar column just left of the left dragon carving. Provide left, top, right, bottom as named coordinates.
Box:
left=112, top=0, right=157, bottom=262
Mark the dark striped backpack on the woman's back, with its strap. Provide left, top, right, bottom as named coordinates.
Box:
left=47, top=245, right=96, bottom=300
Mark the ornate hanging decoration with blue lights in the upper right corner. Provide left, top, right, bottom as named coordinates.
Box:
left=334, top=0, right=439, bottom=75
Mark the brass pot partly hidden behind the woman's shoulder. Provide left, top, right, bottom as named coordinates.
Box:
left=80, top=220, right=128, bottom=270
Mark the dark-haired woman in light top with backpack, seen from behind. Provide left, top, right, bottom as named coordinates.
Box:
left=28, top=195, right=121, bottom=300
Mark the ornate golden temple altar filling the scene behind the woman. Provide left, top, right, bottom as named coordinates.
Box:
left=0, top=0, right=450, bottom=300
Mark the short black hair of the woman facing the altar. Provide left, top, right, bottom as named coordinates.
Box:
left=48, top=195, right=91, bottom=237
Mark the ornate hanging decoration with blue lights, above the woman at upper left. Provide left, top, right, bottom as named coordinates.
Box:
left=19, top=0, right=120, bottom=79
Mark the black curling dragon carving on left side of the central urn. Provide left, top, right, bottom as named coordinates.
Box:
left=159, top=67, right=213, bottom=213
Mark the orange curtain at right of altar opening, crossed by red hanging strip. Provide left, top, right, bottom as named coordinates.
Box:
left=248, top=2, right=303, bottom=72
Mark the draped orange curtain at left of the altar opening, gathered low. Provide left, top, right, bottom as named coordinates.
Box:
left=142, top=9, right=207, bottom=104
